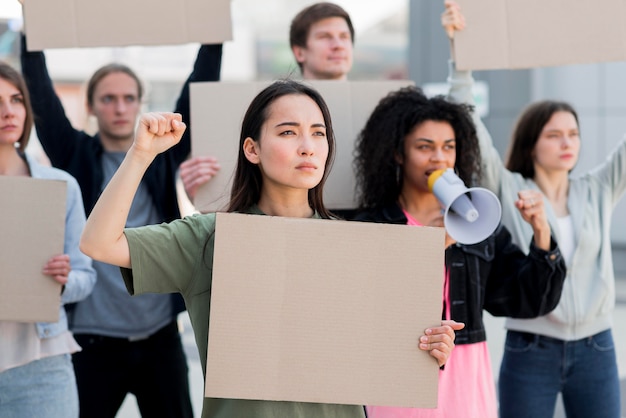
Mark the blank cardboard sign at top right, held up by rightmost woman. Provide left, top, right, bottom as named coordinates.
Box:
left=454, top=0, right=626, bottom=70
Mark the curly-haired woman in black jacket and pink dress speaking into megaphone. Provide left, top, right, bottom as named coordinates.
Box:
left=355, top=87, right=565, bottom=418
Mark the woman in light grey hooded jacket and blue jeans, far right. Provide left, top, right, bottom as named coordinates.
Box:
left=442, top=2, right=626, bottom=418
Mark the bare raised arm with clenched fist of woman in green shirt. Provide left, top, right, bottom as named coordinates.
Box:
left=80, top=113, right=185, bottom=268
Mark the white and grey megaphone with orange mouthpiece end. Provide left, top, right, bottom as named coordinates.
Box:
left=428, top=168, right=502, bottom=244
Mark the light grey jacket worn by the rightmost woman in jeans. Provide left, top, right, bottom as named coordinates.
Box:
left=448, top=63, right=626, bottom=340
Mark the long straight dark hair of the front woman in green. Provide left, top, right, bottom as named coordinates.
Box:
left=227, top=80, right=335, bottom=218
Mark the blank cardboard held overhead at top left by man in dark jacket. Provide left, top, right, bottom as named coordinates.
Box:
left=24, top=0, right=232, bottom=51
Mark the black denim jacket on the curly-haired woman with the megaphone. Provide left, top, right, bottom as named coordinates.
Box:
left=354, top=204, right=566, bottom=344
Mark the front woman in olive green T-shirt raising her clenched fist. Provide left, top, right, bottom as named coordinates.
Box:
left=81, top=81, right=462, bottom=418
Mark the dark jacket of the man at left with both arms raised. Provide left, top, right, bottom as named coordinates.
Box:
left=21, top=37, right=222, bottom=318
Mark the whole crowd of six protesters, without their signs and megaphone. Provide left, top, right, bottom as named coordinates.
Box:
left=0, top=0, right=626, bottom=418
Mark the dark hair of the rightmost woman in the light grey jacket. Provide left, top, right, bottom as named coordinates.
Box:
left=506, top=100, right=578, bottom=179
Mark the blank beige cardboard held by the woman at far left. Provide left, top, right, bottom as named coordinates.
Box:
left=0, top=176, right=66, bottom=322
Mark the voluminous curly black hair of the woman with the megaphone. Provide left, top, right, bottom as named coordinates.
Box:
left=354, top=86, right=481, bottom=210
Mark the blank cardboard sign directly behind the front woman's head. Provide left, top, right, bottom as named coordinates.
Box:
left=190, top=80, right=414, bottom=212
